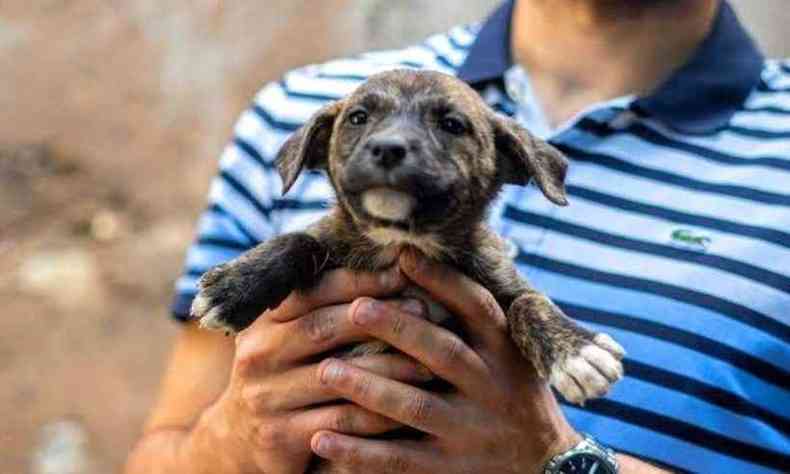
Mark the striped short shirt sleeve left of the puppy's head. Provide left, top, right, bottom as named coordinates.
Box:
left=171, top=83, right=297, bottom=321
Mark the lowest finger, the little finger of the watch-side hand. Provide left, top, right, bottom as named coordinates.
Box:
left=310, top=431, right=434, bottom=474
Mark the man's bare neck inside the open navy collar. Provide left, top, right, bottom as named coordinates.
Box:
left=511, top=0, right=719, bottom=125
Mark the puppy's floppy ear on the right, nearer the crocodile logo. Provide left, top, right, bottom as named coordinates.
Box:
left=491, top=112, right=568, bottom=206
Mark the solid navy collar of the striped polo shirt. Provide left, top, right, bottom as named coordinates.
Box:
left=458, top=0, right=764, bottom=133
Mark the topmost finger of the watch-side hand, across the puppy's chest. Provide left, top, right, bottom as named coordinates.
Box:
left=400, top=250, right=507, bottom=345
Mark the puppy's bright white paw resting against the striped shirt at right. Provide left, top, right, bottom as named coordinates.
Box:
left=549, top=333, right=625, bottom=405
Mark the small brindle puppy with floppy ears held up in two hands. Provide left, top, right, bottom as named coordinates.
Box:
left=192, top=70, right=624, bottom=404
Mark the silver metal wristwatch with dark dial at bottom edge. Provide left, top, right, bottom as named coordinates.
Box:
left=543, top=434, right=620, bottom=474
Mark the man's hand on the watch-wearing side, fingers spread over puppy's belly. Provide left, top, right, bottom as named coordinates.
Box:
left=311, top=252, right=580, bottom=474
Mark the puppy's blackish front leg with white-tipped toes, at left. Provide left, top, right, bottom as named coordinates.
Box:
left=191, top=233, right=329, bottom=332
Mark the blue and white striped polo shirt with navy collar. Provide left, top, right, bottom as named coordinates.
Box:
left=173, top=1, right=790, bottom=473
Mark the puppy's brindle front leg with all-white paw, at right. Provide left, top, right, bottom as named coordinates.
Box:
left=507, top=291, right=625, bottom=405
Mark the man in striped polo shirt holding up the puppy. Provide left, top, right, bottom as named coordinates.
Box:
left=127, top=0, right=790, bottom=474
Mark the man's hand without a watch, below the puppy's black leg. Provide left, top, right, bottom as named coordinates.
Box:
left=183, top=267, right=431, bottom=474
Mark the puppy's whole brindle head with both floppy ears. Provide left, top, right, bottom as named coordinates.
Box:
left=278, top=70, right=566, bottom=239
